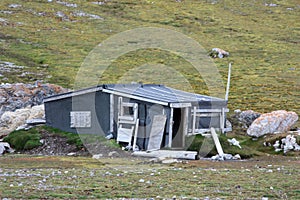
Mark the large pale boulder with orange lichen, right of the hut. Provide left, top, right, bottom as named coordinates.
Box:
left=247, top=110, right=298, bottom=137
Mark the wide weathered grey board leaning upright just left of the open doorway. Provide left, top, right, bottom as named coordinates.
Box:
left=147, top=115, right=167, bottom=151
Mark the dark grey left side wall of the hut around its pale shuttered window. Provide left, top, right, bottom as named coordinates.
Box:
left=45, top=91, right=110, bottom=135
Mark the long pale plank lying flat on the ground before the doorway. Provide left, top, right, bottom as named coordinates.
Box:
left=132, top=150, right=198, bottom=160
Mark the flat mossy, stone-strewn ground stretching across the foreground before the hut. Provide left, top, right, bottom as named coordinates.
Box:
left=0, top=155, right=300, bottom=199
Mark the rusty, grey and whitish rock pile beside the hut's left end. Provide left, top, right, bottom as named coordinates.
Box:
left=0, top=81, right=68, bottom=135
